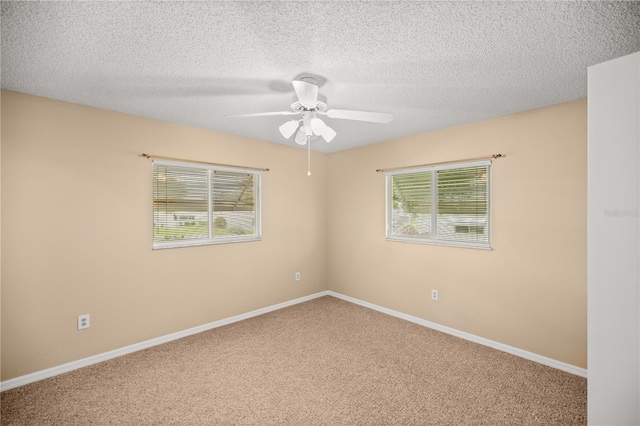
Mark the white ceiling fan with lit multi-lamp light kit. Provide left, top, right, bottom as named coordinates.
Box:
left=227, top=77, right=393, bottom=145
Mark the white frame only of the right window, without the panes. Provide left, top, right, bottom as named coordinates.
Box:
left=385, top=160, right=492, bottom=250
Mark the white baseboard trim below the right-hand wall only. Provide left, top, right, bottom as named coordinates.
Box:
left=328, top=291, right=587, bottom=378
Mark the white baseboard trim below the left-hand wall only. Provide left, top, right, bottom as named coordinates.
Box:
left=0, top=291, right=329, bottom=392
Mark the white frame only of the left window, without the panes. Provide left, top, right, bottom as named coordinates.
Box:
left=151, top=159, right=262, bottom=250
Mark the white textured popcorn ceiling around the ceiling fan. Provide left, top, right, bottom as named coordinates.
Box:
left=0, top=1, right=640, bottom=152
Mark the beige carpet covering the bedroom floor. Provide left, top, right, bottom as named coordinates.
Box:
left=0, top=296, right=587, bottom=426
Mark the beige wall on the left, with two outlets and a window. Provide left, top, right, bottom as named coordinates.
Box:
left=1, top=91, right=327, bottom=380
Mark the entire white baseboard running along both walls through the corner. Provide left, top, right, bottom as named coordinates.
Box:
left=0, top=291, right=587, bottom=392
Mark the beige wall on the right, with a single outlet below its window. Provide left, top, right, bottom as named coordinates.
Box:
left=328, top=99, right=587, bottom=368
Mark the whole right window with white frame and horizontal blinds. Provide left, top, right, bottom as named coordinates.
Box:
left=386, top=161, right=491, bottom=248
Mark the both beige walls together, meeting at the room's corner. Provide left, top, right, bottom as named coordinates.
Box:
left=1, top=91, right=587, bottom=380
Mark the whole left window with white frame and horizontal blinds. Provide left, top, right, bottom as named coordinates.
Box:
left=153, top=160, right=260, bottom=249
